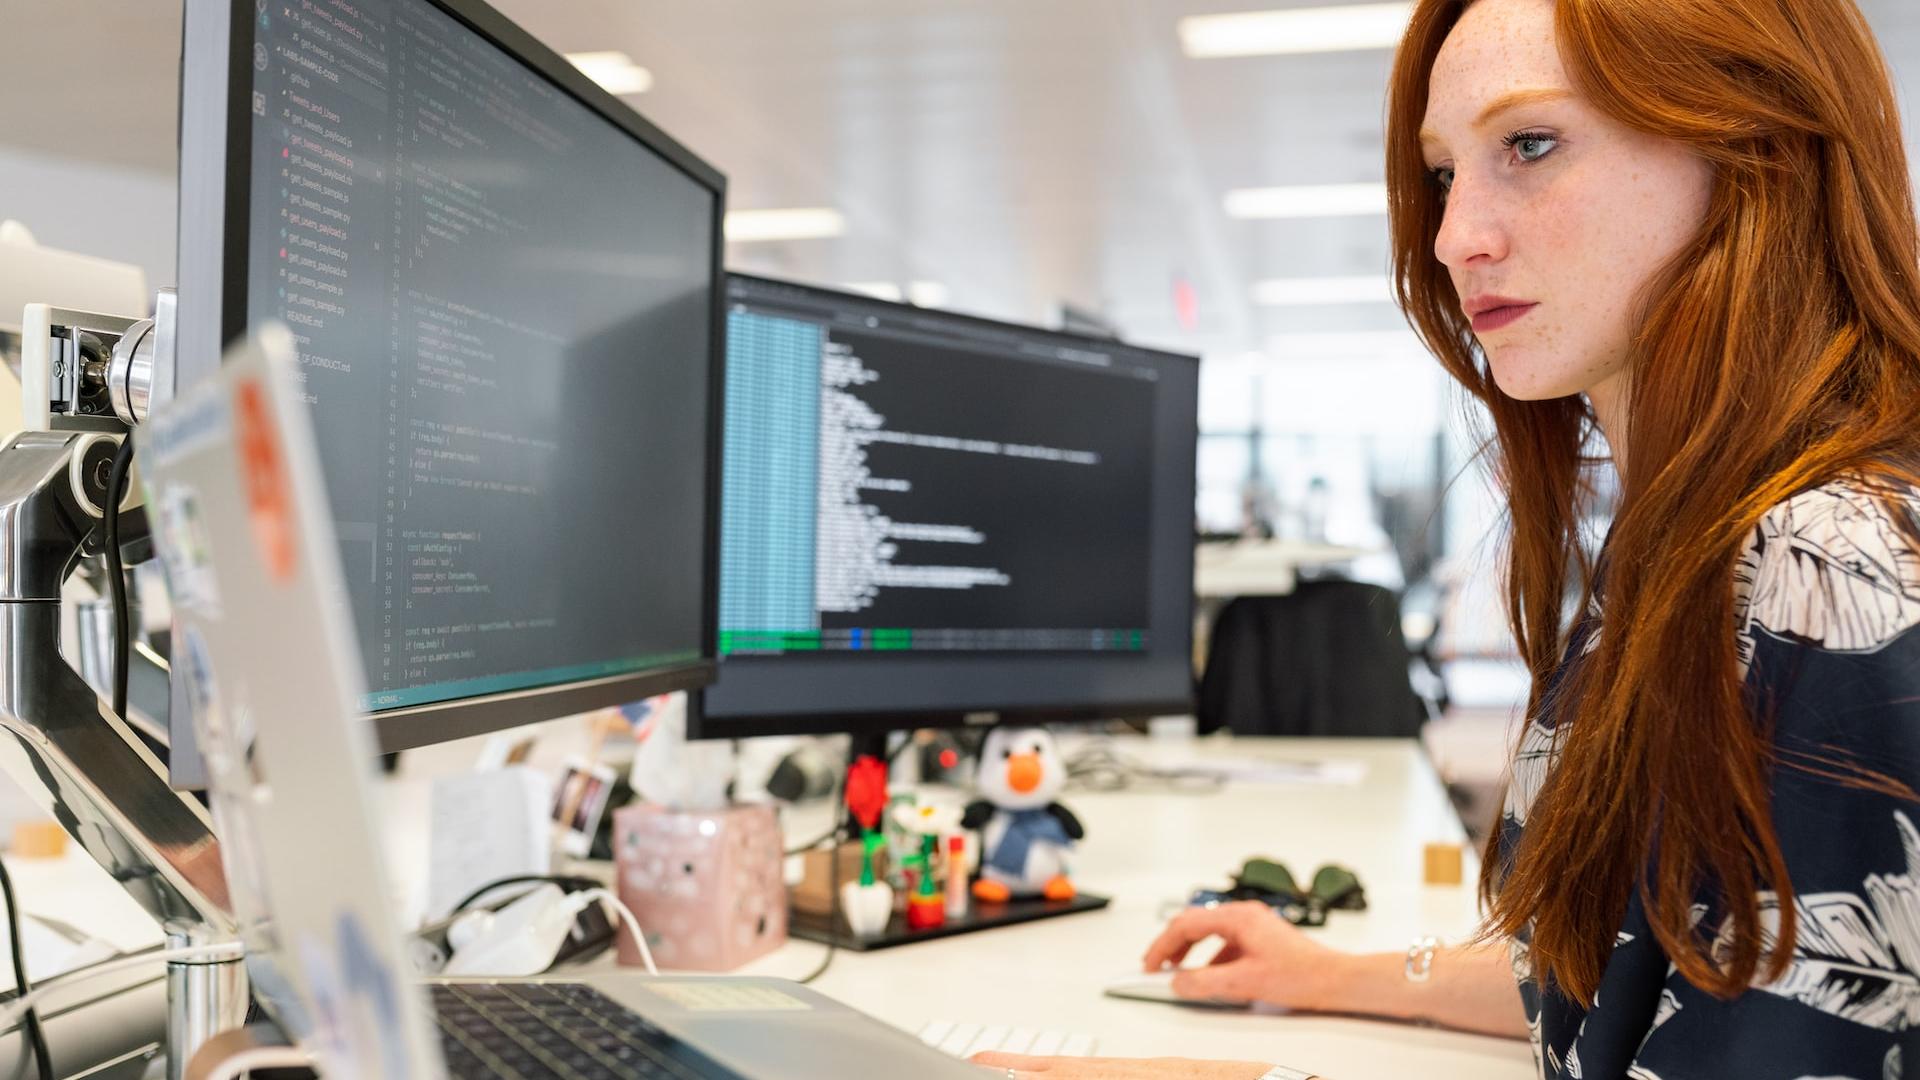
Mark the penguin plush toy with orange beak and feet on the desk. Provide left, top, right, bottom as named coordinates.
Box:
left=960, top=726, right=1087, bottom=903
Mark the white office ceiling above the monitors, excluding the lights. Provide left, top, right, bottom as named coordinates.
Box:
left=11, top=0, right=1920, bottom=354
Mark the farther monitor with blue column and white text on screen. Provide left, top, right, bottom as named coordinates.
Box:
left=695, top=275, right=1198, bottom=738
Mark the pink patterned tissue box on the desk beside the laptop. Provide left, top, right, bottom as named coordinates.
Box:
left=612, top=803, right=787, bottom=970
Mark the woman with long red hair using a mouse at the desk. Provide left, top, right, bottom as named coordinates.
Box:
left=993, top=0, right=1920, bottom=1080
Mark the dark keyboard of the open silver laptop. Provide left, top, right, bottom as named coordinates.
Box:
left=432, top=982, right=741, bottom=1080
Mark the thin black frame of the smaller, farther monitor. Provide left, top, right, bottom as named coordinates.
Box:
left=687, top=271, right=1200, bottom=738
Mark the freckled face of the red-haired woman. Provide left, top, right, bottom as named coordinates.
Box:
left=1421, top=0, right=1713, bottom=400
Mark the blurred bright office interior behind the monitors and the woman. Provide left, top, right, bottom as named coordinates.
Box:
left=11, top=0, right=1920, bottom=814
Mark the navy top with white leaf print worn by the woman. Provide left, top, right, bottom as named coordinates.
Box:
left=1501, top=482, right=1920, bottom=1080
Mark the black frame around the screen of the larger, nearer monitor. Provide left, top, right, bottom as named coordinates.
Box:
left=174, top=0, right=728, bottom=768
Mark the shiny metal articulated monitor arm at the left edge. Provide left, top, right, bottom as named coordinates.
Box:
left=0, top=296, right=248, bottom=1078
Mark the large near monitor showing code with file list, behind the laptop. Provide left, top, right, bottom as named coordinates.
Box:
left=172, top=0, right=726, bottom=782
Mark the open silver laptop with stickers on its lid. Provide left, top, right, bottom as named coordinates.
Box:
left=136, top=325, right=979, bottom=1080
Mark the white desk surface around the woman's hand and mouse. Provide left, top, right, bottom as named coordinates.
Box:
left=721, top=738, right=1532, bottom=1080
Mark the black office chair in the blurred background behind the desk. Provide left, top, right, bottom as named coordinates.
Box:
left=1198, top=580, right=1427, bottom=738
